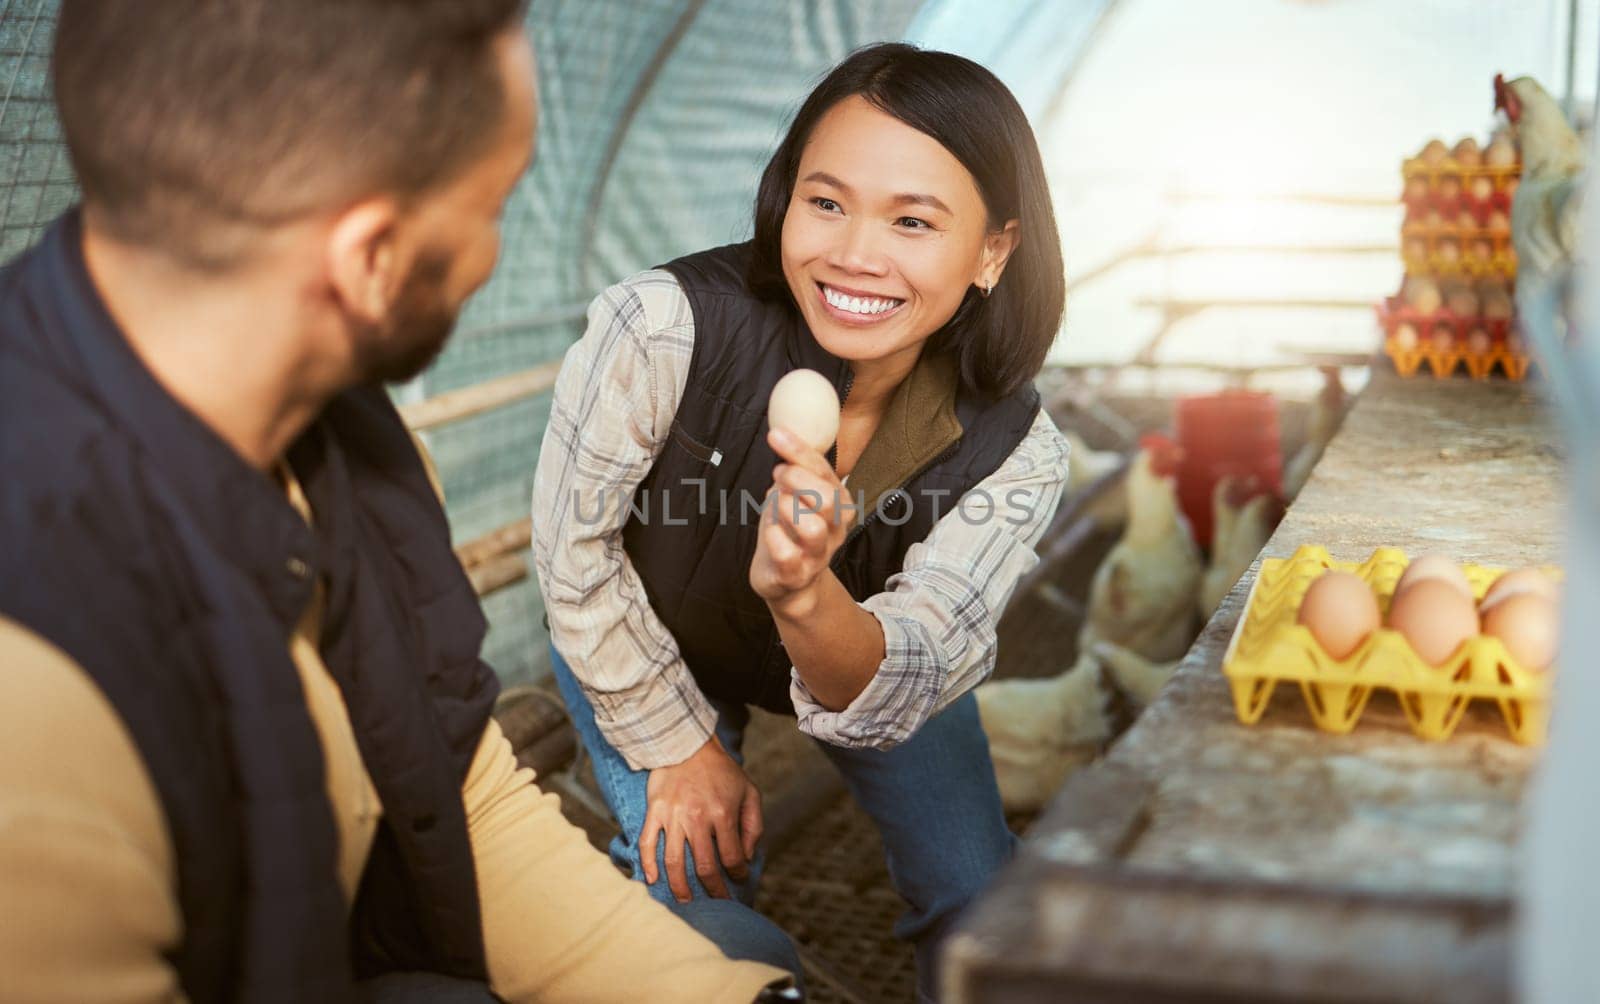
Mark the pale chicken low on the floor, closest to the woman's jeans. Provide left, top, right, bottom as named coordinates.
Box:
left=974, top=654, right=1114, bottom=812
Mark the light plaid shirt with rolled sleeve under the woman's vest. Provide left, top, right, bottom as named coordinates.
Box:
left=533, top=270, right=1067, bottom=769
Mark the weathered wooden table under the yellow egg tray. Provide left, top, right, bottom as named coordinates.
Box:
left=947, top=369, right=1563, bottom=1001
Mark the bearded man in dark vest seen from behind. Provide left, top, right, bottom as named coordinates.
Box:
left=0, top=0, right=782, bottom=1002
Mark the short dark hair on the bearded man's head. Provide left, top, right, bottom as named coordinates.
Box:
left=51, top=0, right=526, bottom=267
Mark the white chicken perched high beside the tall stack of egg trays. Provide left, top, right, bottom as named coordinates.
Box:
left=1494, top=75, right=1586, bottom=291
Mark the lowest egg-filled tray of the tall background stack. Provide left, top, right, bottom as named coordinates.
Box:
left=1378, top=296, right=1533, bottom=380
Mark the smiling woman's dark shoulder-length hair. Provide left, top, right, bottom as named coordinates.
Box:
left=747, top=43, right=1067, bottom=398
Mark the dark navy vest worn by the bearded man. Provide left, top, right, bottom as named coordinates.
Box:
left=0, top=213, right=498, bottom=1004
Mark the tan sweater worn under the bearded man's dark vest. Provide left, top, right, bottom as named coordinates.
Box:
left=0, top=470, right=784, bottom=1004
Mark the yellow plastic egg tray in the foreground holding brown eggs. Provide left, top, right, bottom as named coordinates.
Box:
left=1222, top=545, right=1560, bottom=745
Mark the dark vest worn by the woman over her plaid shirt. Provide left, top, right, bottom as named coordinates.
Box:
left=622, top=245, right=1038, bottom=715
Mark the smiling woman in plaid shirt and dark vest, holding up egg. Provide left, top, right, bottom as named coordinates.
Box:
left=533, top=45, right=1066, bottom=998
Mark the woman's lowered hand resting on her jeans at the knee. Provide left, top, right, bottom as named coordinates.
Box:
left=638, top=735, right=762, bottom=903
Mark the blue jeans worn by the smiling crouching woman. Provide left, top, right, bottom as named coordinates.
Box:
left=550, top=647, right=1016, bottom=1001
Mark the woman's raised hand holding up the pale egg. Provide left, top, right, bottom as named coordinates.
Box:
left=750, top=428, right=850, bottom=612
